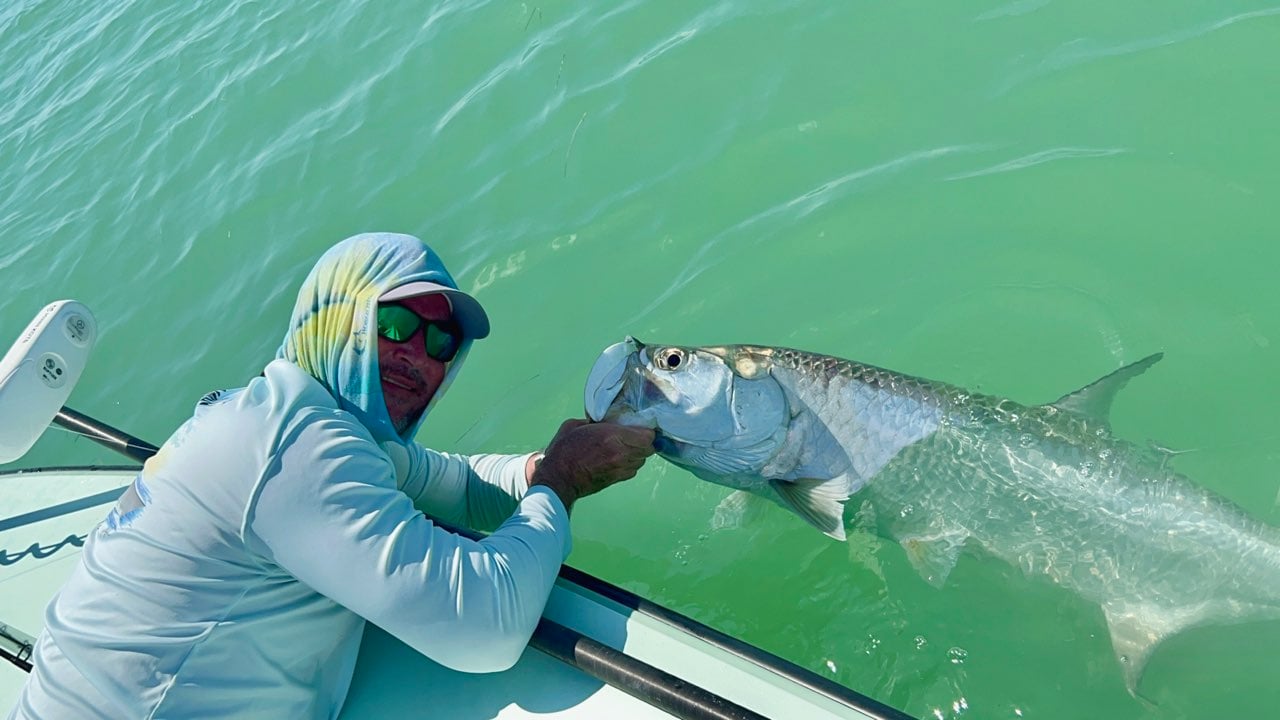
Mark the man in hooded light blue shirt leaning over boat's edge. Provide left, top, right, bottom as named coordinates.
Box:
left=10, top=233, right=653, bottom=719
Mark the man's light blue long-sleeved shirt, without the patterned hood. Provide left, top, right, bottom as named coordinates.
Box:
left=10, top=360, right=570, bottom=719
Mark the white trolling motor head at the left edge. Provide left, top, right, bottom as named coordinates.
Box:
left=0, top=300, right=97, bottom=464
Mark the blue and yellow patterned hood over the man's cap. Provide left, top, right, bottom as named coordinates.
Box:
left=276, top=233, right=472, bottom=443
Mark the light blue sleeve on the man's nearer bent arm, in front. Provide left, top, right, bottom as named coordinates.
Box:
left=244, top=418, right=570, bottom=673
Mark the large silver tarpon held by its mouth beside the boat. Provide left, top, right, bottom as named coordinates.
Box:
left=586, top=338, right=1280, bottom=692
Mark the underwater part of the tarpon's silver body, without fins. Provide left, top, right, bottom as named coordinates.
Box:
left=870, top=358, right=1280, bottom=604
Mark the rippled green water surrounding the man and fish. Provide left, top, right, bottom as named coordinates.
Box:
left=0, top=0, right=1280, bottom=719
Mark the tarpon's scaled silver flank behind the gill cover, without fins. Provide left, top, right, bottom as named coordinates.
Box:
left=773, top=350, right=1280, bottom=612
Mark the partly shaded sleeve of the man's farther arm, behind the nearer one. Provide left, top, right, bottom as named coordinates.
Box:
left=383, top=442, right=536, bottom=532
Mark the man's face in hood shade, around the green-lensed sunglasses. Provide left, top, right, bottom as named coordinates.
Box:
left=378, top=295, right=449, bottom=432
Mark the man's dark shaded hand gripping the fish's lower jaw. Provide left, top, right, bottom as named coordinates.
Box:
left=530, top=419, right=653, bottom=509
